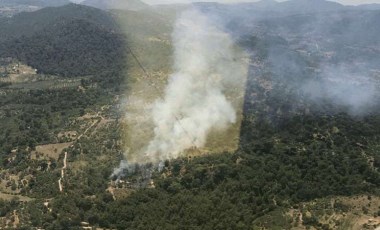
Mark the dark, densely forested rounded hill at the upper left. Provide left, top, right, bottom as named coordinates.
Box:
left=0, top=4, right=123, bottom=76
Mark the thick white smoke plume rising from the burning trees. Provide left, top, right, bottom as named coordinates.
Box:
left=114, top=9, right=247, bottom=178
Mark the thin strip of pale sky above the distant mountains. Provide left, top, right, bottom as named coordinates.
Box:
left=142, top=0, right=380, bottom=5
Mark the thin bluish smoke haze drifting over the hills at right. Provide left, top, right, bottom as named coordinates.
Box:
left=243, top=10, right=380, bottom=117
